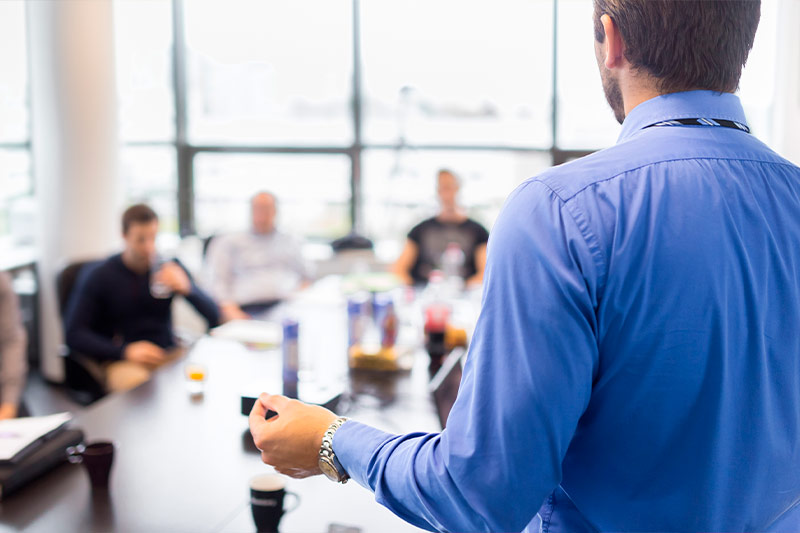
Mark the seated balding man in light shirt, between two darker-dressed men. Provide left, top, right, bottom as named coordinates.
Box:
left=207, top=192, right=309, bottom=321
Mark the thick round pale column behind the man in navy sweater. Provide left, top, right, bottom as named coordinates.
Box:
left=27, top=0, right=120, bottom=381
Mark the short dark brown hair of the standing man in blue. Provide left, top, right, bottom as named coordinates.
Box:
left=594, top=0, right=761, bottom=94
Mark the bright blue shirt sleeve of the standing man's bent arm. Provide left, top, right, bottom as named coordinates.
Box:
left=333, top=181, right=598, bottom=531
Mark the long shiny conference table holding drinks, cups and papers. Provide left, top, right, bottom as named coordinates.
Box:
left=0, top=278, right=476, bottom=533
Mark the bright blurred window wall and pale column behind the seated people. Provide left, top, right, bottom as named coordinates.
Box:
left=0, top=0, right=800, bottom=379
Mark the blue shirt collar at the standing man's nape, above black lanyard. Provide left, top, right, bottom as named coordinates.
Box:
left=617, top=91, right=747, bottom=143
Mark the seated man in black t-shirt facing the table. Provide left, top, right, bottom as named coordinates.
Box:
left=392, top=170, right=489, bottom=286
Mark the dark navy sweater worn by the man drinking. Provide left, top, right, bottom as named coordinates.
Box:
left=65, top=254, right=219, bottom=360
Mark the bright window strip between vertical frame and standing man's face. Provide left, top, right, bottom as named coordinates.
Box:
left=556, top=0, right=620, bottom=150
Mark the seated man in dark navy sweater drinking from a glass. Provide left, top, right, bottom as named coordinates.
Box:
left=65, top=204, right=219, bottom=391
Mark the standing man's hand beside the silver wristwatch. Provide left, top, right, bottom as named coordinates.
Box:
left=250, top=393, right=336, bottom=478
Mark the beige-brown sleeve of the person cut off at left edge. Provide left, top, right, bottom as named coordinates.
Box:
left=0, top=272, right=28, bottom=405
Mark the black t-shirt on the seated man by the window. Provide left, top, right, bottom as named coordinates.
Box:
left=408, top=217, right=489, bottom=283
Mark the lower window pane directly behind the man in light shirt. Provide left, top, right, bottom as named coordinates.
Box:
left=194, top=153, right=350, bottom=239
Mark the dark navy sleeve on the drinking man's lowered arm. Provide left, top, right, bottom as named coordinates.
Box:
left=64, top=267, right=125, bottom=360
